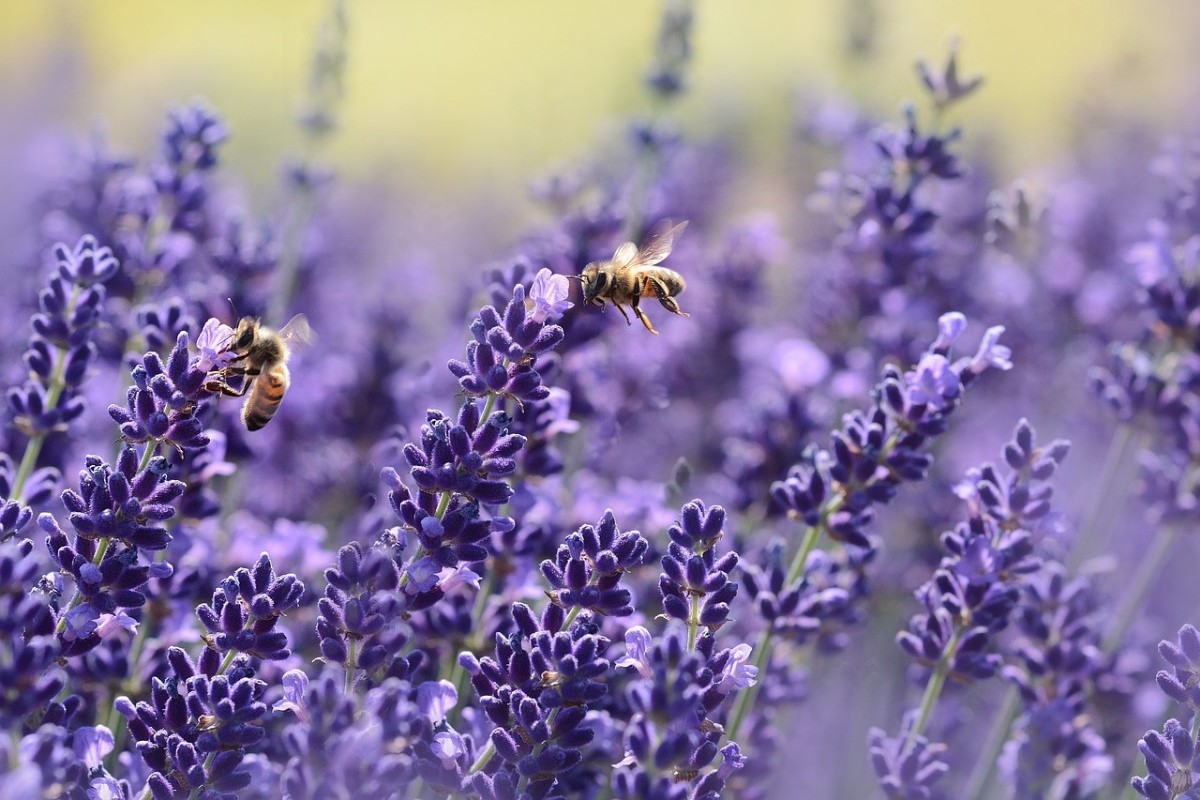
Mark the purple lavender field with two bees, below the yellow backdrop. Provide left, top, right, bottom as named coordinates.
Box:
left=0, top=0, right=1200, bottom=800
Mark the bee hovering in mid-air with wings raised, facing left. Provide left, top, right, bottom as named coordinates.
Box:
left=578, top=219, right=688, bottom=336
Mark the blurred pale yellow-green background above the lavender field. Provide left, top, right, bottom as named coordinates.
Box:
left=0, top=0, right=1198, bottom=206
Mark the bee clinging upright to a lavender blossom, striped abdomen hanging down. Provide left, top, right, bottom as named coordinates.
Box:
left=208, top=314, right=312, bottom=431
